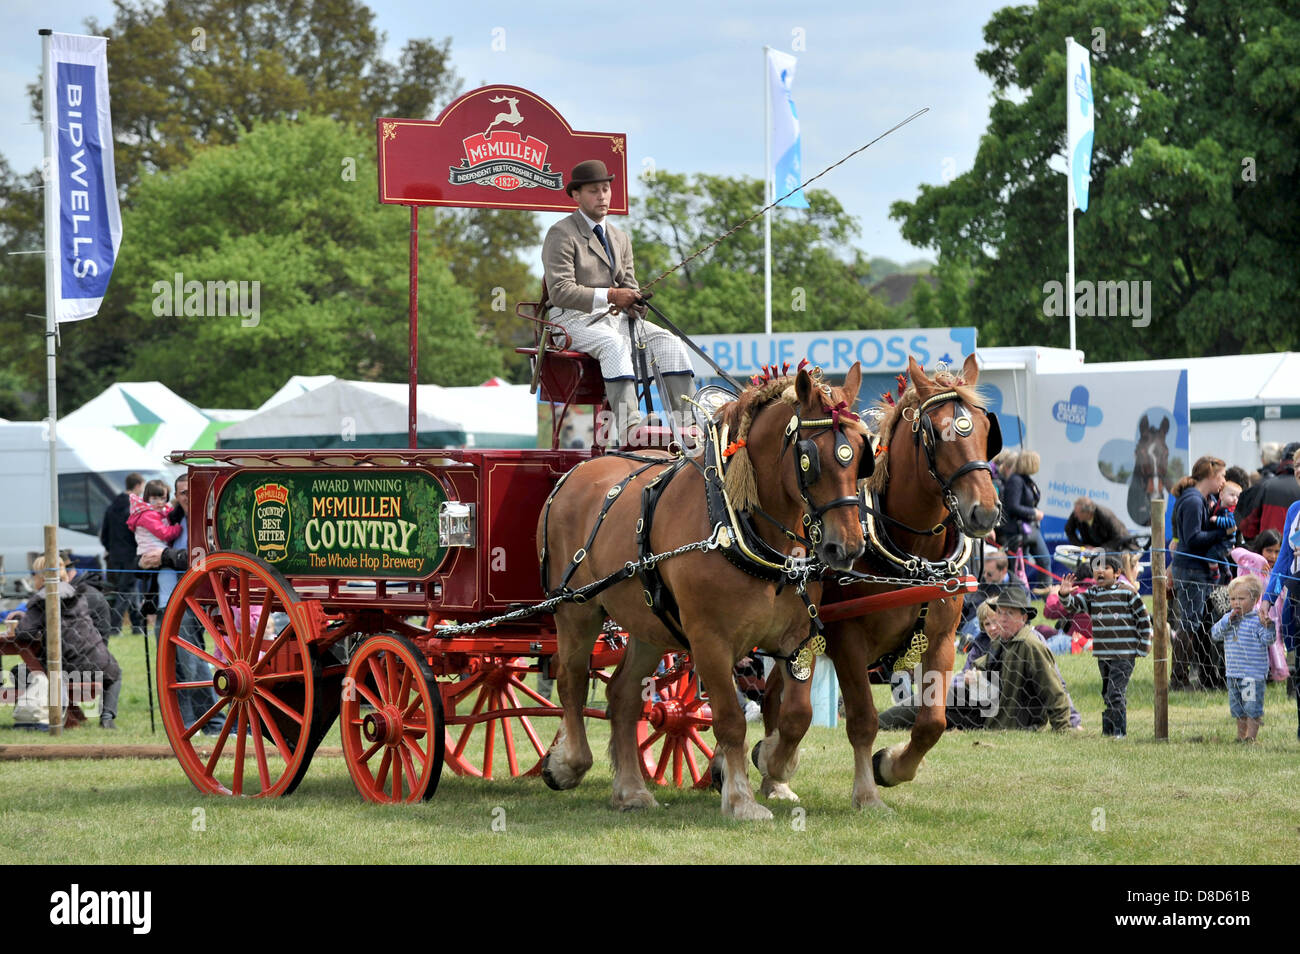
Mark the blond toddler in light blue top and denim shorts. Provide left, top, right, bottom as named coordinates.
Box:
left=1210, top=576, right=1274, bottom=742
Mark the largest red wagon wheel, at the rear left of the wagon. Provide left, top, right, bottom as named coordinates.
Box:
left=157, top=552, right=320, bottom=798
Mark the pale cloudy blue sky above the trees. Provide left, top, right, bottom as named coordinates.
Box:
left=0, top=0, right=1009, bottom=261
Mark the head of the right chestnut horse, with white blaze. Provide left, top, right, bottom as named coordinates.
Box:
left=875, top=355, right=1002, bottom=537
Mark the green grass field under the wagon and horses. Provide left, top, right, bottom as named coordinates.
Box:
left=0, top=636, right=1300, bottom=864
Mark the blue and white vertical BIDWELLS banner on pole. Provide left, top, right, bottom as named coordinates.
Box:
left=46, top=34, right=122, bottom=321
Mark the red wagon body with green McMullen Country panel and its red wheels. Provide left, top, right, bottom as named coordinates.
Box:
left=159, top=428, right=711, bottom=801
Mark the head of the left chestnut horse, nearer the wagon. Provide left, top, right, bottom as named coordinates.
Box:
left=727, top=364, right=874, bottom=569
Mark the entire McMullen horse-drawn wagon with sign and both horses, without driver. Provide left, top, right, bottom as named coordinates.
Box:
left=157, top=87, right=1000, bottom=818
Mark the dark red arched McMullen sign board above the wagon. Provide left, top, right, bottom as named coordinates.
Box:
left=376, top=86, right=628, bottom=216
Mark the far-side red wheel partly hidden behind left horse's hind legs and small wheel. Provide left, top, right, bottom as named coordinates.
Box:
left=439, top=656, right=563, bottom=779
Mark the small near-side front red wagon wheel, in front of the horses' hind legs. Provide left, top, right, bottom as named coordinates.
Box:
left=342, top=633, right=443, bottom=802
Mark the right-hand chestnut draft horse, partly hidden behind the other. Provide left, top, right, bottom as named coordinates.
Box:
left=754, top=355, right=1002, bottom=808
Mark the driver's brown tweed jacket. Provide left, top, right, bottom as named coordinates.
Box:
left=542, top=211, right=640, bottom=315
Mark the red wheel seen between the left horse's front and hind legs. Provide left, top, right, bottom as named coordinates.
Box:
left=637, top=654, right=714, bottom=789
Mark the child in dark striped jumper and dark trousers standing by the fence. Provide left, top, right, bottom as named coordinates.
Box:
left=1057, top=554, right=1152, bottom=738
